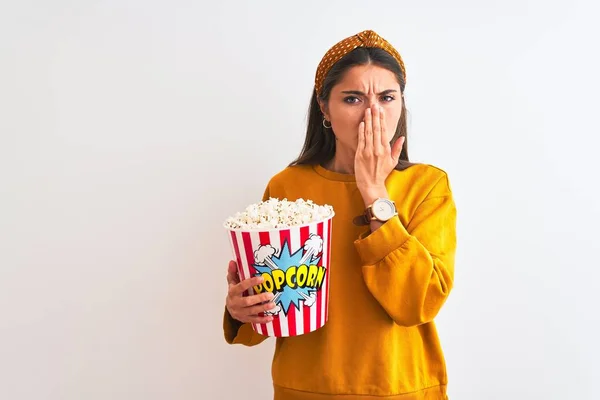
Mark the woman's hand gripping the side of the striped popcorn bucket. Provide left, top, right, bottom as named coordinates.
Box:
left=225, top=260, right=275, bottom=324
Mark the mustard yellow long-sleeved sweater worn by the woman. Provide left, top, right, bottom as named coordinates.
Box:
left=224, top=164, right=456, bottom=400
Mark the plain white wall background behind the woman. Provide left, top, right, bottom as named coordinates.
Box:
left=0, top=0, right=600, bottom=400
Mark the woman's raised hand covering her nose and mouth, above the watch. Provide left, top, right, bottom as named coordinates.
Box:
left=354, top=105, right=404, bottom=204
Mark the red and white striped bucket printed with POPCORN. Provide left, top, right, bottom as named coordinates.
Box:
left=227, top=213, right=333, bottom=337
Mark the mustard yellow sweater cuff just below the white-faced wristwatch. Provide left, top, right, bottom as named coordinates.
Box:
left=354, top=216, right=411, bottom=265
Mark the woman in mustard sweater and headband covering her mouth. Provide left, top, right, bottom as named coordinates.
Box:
left=224, top=31, right=456, bottom=400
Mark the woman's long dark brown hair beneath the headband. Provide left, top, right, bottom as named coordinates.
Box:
left=290, top=47, right=414, bottom=171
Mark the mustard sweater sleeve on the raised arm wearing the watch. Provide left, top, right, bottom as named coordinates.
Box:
left=355, top=173, right=456, bottom=326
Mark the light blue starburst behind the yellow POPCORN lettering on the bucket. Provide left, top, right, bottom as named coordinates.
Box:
left=254, top=241, right=321, bottom=315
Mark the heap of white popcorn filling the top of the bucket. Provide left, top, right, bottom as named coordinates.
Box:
left=225, top=197, right=333, bottom=230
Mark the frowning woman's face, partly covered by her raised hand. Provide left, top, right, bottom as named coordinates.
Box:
left=321, top=64, right=402, bottom=151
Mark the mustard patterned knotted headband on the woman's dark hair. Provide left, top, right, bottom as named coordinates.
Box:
left=315, top=30, right=406, bottom=95
